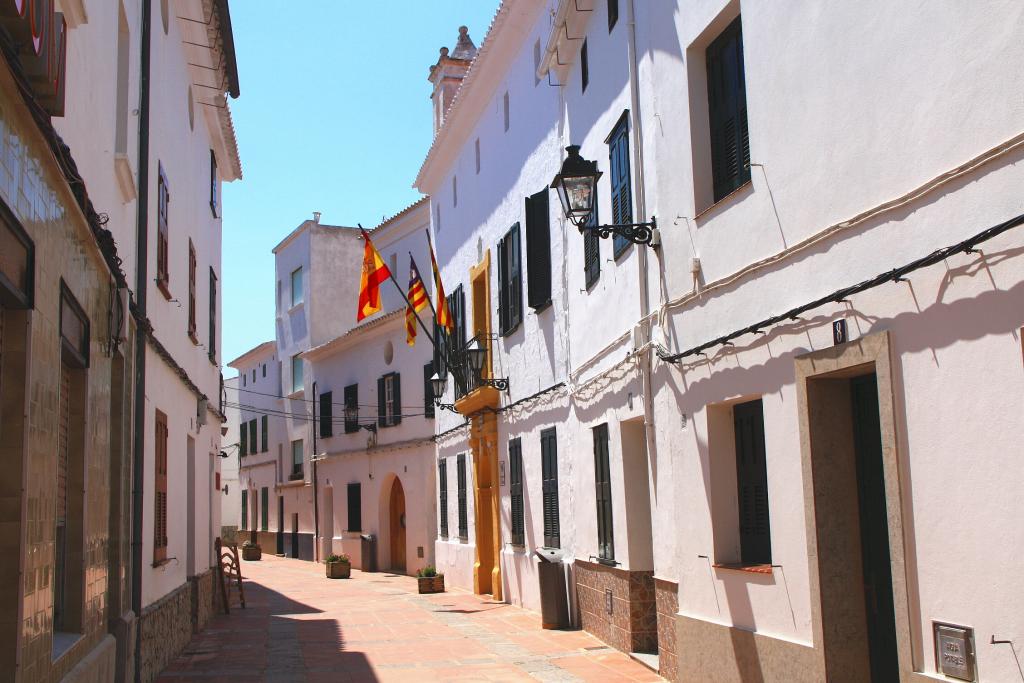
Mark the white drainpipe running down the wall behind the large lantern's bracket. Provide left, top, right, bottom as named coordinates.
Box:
left=629, top=0, right=657, bottom=518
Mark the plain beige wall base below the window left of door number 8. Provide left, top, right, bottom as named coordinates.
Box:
left=670, top=614, right=825, bottom=683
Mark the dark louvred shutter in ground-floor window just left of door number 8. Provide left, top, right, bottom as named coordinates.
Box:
left=732, top=398, right=771, bottom=564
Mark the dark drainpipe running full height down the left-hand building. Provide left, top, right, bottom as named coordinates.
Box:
left=131, top=0, right=153, bottom=683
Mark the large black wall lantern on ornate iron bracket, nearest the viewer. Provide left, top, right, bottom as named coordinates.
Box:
left=551, top=144, right=662, bottom=247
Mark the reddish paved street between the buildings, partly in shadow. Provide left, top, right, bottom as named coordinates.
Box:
left=159, top=555, right=663, bottom=683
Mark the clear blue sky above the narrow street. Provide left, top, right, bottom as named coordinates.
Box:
left=222, top=0, right=499, bottom=370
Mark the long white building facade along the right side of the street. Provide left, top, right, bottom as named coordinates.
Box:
left=416, top=0, right=1024, bottom=681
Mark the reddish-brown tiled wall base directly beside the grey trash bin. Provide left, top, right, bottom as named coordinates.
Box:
left=573, top=559, right=657, bottom=652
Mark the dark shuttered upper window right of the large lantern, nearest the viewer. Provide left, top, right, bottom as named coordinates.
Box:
left=705, top=16, right=751, bottom=202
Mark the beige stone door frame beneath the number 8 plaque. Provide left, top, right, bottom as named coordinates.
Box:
left=794, top=331, right=923, bottom=681
